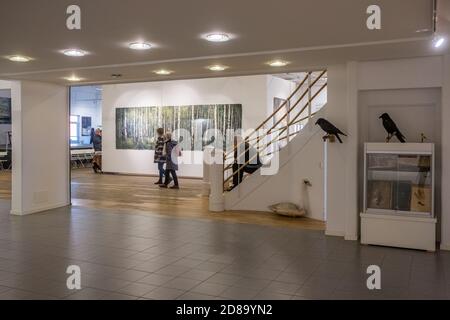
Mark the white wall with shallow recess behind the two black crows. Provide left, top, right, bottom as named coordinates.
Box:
left=327, top=56, right=450, bottom=244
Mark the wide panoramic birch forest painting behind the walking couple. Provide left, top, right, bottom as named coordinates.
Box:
left=116, top=104, right=242, bottom=151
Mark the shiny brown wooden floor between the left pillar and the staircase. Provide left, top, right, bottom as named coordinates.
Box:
left=72, top=169, right=324, bottom=230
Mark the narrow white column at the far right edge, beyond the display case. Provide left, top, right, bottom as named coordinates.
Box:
left=441, top=55, right=450, bottom=250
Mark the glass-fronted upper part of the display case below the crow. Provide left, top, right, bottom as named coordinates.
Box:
left=364, top=143, right=434, bottom=217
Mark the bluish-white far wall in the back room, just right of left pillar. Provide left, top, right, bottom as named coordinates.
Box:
left=70, top=86, right=102, bottom=144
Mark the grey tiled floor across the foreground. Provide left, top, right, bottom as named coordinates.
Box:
left=0, top=200, right=450, bottom=299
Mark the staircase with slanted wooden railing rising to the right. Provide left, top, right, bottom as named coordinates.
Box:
left=216, top=70, right=327, bottom=218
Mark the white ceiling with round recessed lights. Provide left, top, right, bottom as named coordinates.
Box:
left=0, top=0, right=450, bottom=83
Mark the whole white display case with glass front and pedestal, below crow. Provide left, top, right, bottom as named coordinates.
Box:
left=361, top=143, right=436, bottom=251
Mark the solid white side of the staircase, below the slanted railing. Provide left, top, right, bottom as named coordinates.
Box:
left=224, top=107, right=325, bottom=220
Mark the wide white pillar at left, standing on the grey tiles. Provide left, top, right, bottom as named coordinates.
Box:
left=11, top=81, right=70, bottom=215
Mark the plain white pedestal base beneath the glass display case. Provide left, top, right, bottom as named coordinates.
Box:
left=361, top=213, right=437, bottom=251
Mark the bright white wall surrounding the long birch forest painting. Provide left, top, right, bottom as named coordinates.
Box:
left=102, top=76, right=267, bottom=177
